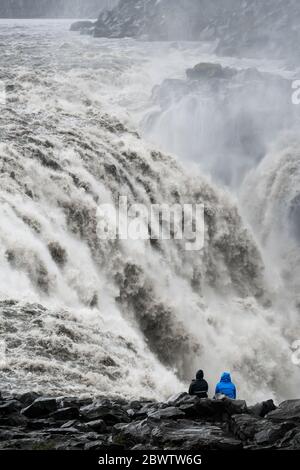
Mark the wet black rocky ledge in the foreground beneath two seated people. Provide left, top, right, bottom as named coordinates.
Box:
left=0, top=392, right=300, bottom=451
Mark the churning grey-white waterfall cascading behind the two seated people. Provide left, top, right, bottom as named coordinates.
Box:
left=0, top=21, right=299, bottom=401
